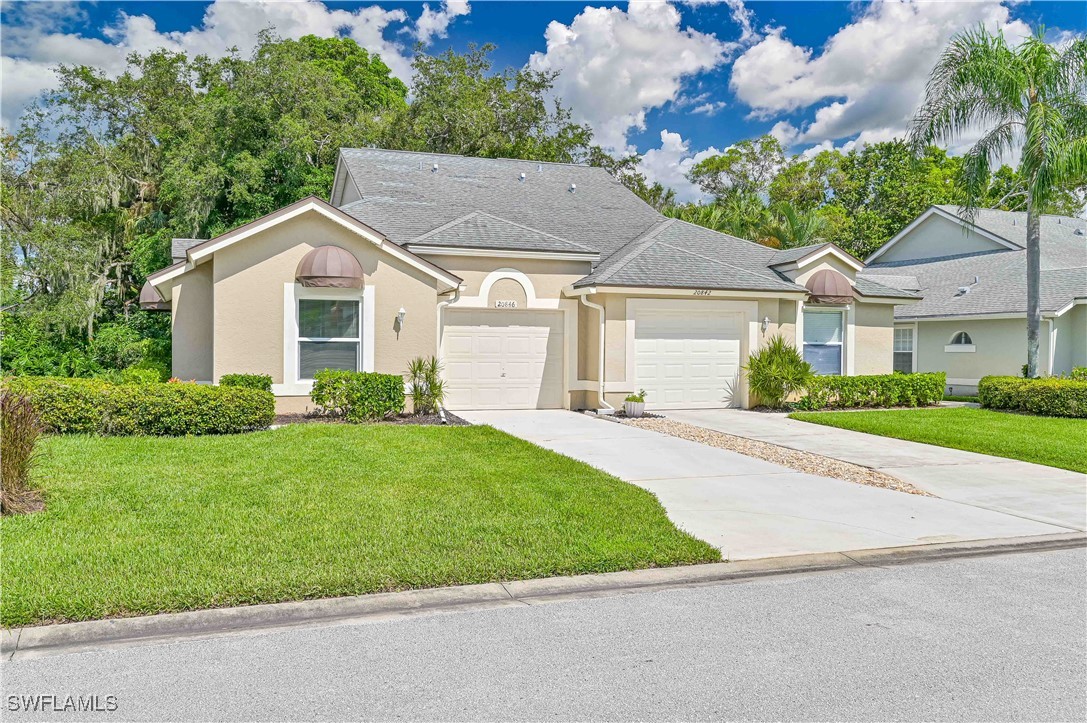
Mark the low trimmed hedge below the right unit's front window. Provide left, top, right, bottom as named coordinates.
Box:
left=797, top=372, right=947, bottom=410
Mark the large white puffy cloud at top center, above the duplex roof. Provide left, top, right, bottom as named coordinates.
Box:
left=528, top=2, right=739, bottom=151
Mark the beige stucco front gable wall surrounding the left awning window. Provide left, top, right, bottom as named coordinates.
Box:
left=213, top=212, right=437, bottom=384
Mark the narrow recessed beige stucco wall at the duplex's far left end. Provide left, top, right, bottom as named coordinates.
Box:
left=171, top=263, right=214, bottom=382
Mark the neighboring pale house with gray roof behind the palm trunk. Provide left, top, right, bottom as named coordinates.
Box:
left=861, top=205, right=1087, bottom=394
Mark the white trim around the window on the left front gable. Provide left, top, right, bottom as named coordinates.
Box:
left=272, top=283, right=374, bottom=397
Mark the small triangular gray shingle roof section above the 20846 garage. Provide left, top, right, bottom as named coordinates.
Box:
left=408, top=211, right=592, bottom=253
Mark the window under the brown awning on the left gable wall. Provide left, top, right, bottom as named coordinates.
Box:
left=298, top=299, right=362, bottom=379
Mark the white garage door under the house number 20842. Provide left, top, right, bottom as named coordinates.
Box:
left=634, top=308, right=742, bottom=409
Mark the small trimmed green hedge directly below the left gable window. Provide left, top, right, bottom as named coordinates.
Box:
left=310, top=369, right=404, bottom=422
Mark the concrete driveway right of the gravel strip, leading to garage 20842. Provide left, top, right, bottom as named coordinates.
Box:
left=666, top=409, right=1087, bottom=531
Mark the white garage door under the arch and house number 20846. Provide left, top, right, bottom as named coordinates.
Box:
left=442, top=309, right=563, bottom=409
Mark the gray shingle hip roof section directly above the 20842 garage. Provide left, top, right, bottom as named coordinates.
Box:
left=574, top=219, right=803, bottom=291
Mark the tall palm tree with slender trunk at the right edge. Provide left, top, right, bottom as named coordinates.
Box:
left=910, top=28, right=1087, bottom=377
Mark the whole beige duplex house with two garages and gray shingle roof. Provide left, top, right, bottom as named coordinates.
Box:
left=141, top=149, right=919, bottom=410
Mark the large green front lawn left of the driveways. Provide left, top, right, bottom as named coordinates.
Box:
left=0, top=424, right=721, bottom=626
